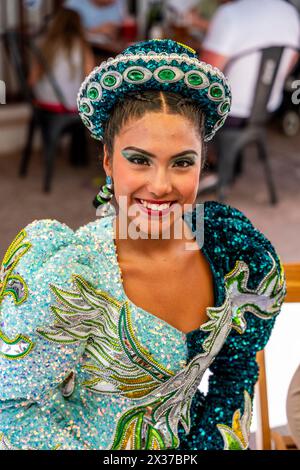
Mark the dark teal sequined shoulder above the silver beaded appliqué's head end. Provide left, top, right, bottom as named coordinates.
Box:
left=199, top=201, right=282, bottom=288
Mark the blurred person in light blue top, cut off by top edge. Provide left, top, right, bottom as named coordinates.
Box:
left=64, top=0, right=126, bottom=39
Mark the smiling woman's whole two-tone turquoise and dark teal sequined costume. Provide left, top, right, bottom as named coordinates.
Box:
left=0, top=201, right=286, bottom=450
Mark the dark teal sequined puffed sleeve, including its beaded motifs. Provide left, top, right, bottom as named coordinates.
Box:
left=179, top=202, right=286, bottom=450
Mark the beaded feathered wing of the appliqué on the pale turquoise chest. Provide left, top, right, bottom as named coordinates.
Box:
left=37, top=275, right=174, bottom=398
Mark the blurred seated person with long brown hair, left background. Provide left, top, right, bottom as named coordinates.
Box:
left=28, top=8, right=95, bottom=162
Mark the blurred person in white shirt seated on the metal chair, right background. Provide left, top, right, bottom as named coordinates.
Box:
left=201, top=0, right=300, bottom=187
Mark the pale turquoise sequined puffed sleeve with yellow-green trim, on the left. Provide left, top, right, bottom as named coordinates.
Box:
left=0, top=219, right=95, bottom=449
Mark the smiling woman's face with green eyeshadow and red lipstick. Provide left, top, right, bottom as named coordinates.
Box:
left=104, top=112, right=202, bottom=238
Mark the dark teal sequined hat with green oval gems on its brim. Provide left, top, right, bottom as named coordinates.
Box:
left=77, top=39, right=231, bottom=142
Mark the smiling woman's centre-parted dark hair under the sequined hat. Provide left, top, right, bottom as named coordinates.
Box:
left=103, top=90, right=206, bottom=168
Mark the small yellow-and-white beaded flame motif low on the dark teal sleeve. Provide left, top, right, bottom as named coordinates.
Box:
left=217, top=390, right=252, bottom=450
